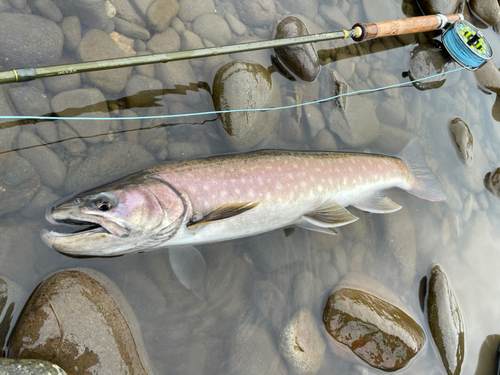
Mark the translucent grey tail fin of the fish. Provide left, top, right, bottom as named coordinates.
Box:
left=396, top=137, right=446, bottom=201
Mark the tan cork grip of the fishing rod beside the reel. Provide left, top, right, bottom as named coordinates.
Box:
left=353, top=14, right=463, bottom=42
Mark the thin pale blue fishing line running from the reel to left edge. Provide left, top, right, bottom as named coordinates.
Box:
left=0, top=67, right=467, bottom=121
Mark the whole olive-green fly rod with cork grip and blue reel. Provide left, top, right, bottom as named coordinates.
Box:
left=0, top=14, right=492, bottom=84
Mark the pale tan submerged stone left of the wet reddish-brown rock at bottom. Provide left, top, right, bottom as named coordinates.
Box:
left=280, top=309, right=326, bottom=374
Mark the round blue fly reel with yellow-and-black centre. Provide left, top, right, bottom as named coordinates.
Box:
left=443, top=20, right=493, bottom=70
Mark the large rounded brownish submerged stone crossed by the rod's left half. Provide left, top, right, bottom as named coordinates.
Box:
left=77, top=29, right=132, bottom=92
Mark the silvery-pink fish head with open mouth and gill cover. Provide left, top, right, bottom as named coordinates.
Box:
left=41, top=174, right=186, bottom=256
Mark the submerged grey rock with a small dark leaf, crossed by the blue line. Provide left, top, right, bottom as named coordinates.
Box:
left=319, top=69, right=380, bottom=147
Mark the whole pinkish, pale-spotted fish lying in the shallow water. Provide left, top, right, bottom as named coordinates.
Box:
left=41, top=138, right=446, bottom=256
